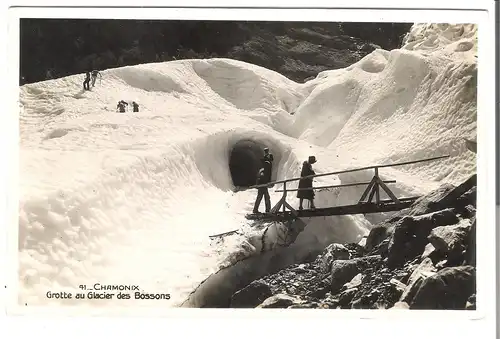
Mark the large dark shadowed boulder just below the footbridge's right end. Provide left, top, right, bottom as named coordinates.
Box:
left=387, top=209, right=458, bottom=268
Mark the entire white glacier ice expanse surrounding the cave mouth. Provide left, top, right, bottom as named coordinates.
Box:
left=19, top=25, right=476, bottom=307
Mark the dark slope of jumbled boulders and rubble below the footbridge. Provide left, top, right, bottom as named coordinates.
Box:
left=230, top=175, right=476, bottom=310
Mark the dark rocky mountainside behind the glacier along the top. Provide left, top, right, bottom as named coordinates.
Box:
left=19, top=19, right=411, bottom=85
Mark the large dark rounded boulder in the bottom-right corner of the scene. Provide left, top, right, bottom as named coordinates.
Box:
left=410, top=266, right=476, bottom=310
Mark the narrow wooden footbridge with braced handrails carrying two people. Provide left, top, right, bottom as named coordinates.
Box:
left=246, top=155, right=449, bottom=221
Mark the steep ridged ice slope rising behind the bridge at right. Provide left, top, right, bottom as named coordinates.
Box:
left=294, top=25, right=477, bottom=183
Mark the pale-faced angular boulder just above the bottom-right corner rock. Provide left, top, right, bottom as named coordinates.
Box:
left=428, top=221, right=472, bottom=264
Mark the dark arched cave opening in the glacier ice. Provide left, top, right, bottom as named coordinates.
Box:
left=229, top=140, right=266, bottom=187
